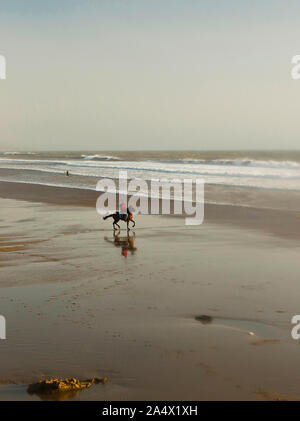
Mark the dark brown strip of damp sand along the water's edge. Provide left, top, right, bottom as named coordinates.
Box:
left=0, top=181, right=300, bottom=240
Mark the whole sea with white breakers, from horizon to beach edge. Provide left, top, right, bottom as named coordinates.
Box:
left=0, top=151, right=300, bottom=209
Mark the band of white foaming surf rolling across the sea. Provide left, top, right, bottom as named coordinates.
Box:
left=0, top=154, right=300, bottom=190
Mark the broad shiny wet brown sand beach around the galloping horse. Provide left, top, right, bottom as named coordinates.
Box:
left=0, top=183, right=300, bottom=400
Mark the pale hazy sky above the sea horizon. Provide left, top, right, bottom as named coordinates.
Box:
left=0, top=0, right=300, bottom=150
